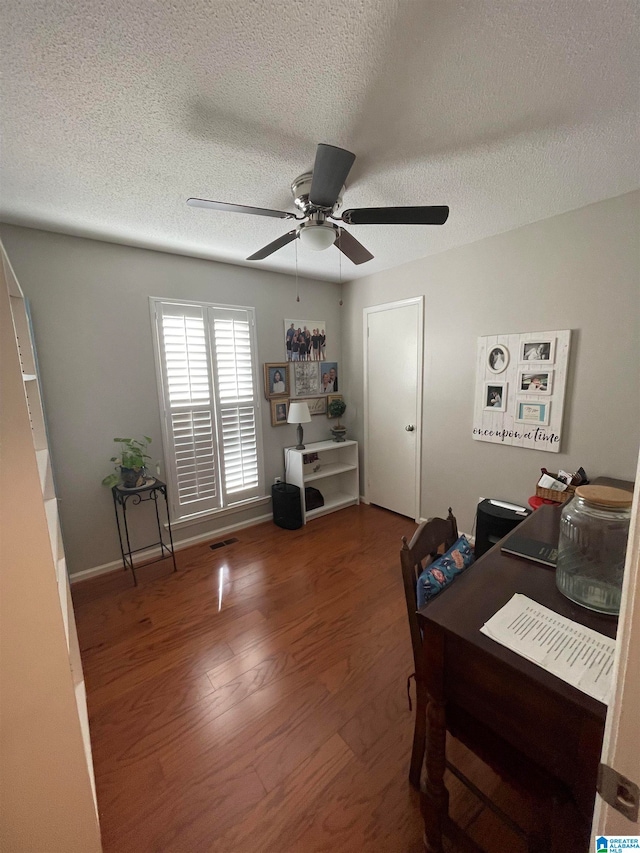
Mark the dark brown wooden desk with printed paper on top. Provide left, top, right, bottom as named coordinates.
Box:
left=419, top=506, right=617, bottom=853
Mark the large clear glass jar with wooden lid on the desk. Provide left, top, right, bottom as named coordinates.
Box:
left=556, top=486, right=633, bottom=614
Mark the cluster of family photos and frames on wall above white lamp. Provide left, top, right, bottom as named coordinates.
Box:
left=264, top=319, right=342, bottom=426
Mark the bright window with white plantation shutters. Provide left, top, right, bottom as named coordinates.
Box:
left=151, top=298, right=264, bottom=520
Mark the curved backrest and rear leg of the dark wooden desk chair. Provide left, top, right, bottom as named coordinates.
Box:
left=400, top=507, right=458, bottom=789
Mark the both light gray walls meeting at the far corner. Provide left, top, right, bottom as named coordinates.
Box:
left=0, top=192, right=640, bottom=573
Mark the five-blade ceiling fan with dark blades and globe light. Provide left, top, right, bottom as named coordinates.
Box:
left=187, top=142, right=449, bottom=264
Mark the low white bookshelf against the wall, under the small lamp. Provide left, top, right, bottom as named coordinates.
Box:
left=284, top=441, right=360, bottom=524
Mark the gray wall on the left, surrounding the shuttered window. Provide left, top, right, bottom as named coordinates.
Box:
left=0, top=225, right=342, bottom=574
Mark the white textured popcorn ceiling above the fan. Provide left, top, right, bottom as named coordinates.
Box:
left=0, top=0, right=640, bottom=280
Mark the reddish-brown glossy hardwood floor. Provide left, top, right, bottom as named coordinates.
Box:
left=73, top=506, right=526, bottom=853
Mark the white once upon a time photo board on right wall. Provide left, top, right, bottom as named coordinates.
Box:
left=473, top=329, right=571, bottom=453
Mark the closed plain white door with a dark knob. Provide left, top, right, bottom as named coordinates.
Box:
left=364, top=297, right=424, bottom=520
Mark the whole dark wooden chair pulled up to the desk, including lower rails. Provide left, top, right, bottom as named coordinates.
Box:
left=400, top=507, right=567, bottom=853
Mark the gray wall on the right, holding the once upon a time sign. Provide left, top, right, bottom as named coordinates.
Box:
left=343, top=192, right=640, bottom=531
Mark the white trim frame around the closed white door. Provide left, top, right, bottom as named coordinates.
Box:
left=362, top=295, right=424, bottom=523
